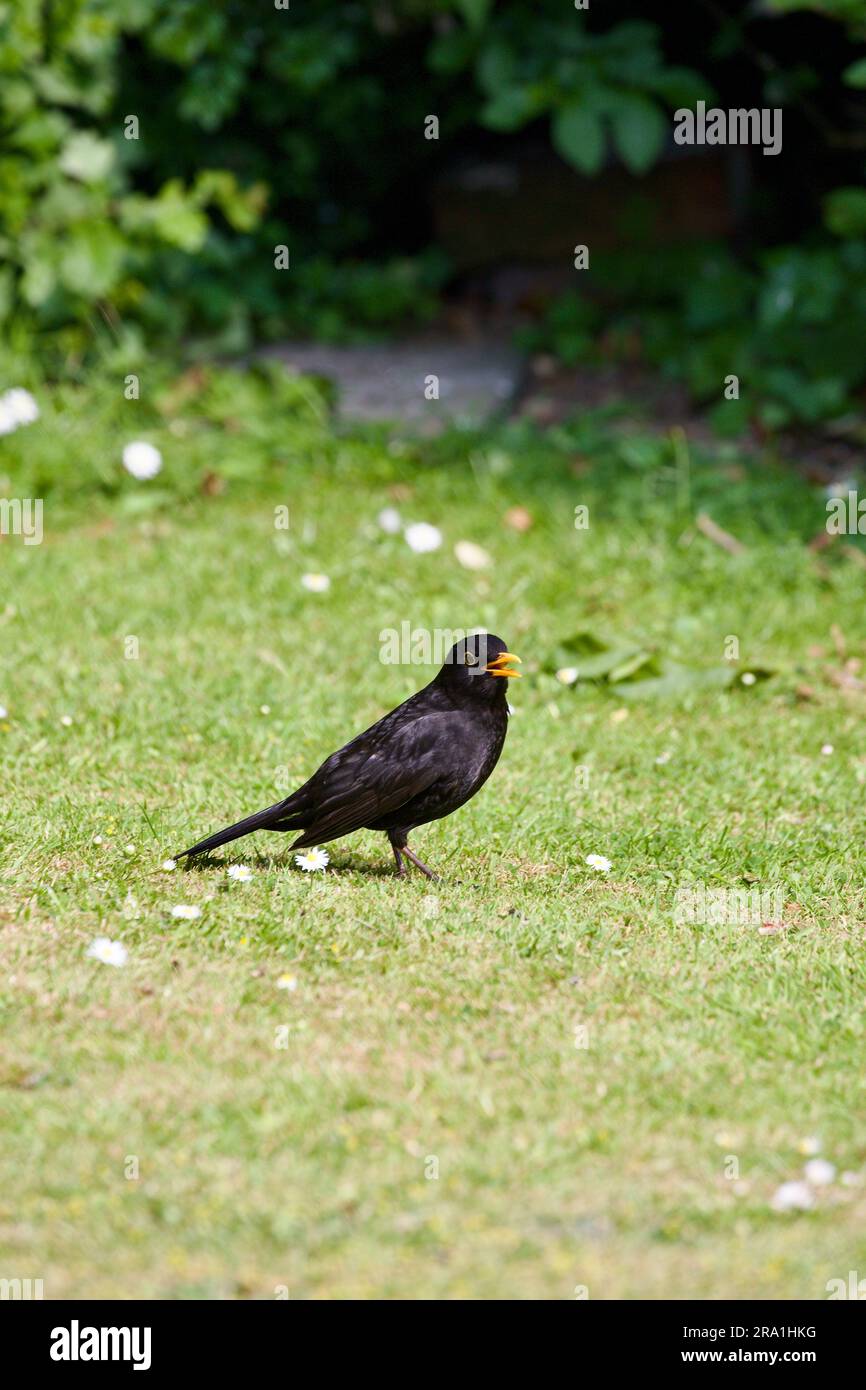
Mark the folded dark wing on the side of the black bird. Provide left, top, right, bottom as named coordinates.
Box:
left=292, top=713, right=453, bottom=848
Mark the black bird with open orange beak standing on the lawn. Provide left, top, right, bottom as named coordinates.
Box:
left=176, top=632, right=520, bottom=878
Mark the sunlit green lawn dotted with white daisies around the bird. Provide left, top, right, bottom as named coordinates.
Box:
left=0, top=375, right=866, bottom=1298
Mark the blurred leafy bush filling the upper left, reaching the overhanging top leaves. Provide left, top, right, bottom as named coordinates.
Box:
left=0, top=0, right=705, bottom=356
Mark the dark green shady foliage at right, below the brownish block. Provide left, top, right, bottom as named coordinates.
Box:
left=520, top=239, right=866, bottom=435
